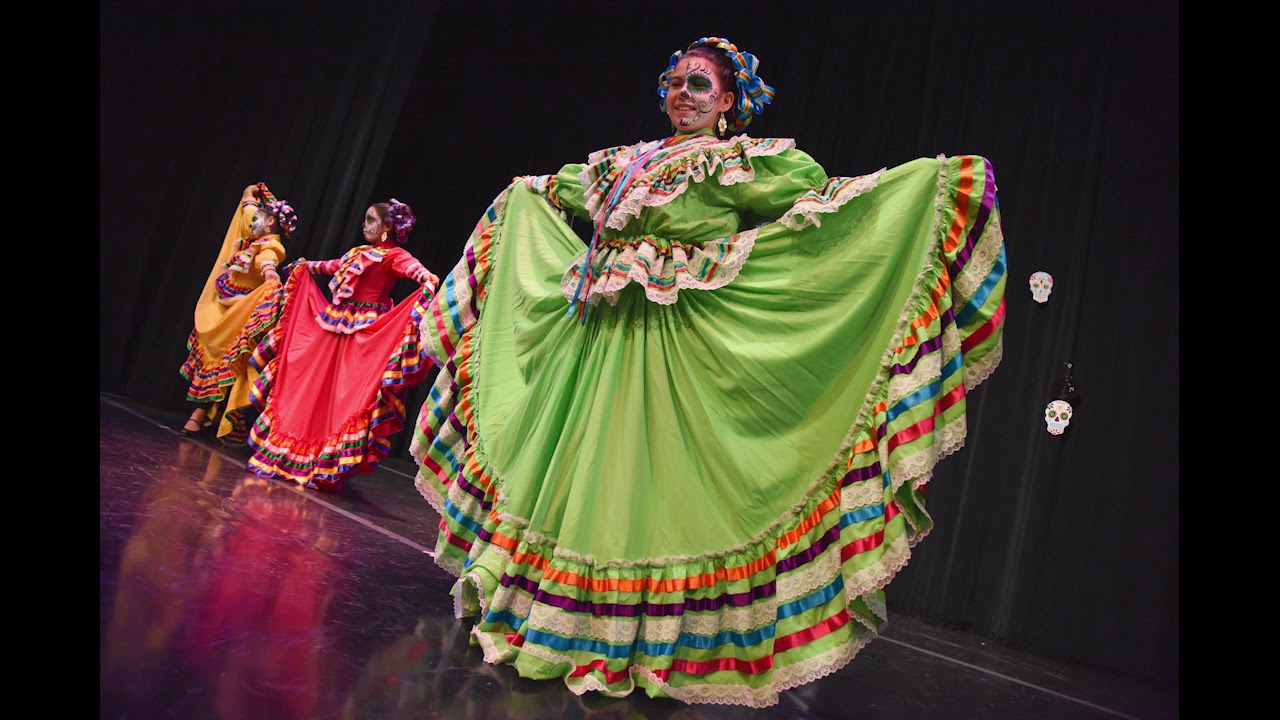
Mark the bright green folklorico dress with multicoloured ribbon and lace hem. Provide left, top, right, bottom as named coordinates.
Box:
left=412, top=126, right=1006, bottom=707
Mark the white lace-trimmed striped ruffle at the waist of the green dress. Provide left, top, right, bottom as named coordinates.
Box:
left=561, top=228, right=760, bottom=306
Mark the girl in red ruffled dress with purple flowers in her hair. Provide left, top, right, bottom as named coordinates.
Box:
left=248, top=199, right=440, bottom=491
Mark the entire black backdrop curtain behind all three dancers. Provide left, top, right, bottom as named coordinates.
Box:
left=100, top=0, right=1180, bottom=685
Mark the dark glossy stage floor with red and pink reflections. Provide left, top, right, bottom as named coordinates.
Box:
left=99, top=395, right=1179, bottom=720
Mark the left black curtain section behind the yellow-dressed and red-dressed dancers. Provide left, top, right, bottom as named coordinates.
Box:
left=99, top=0, right=433, bottom=407
